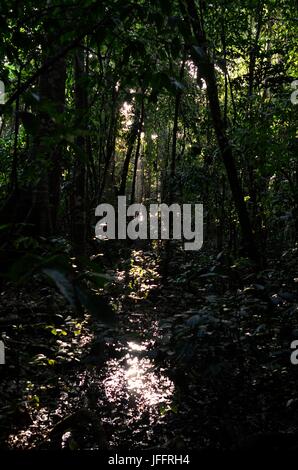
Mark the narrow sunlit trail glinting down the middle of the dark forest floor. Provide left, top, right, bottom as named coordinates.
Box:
left=69, top=246, right=205, bottom=449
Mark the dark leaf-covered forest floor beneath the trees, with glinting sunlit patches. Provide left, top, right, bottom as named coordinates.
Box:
left=0, top=244, right=298, bottom=450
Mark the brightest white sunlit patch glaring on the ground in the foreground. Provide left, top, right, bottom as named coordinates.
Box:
left=98, top=342, right=174, bottom=446
